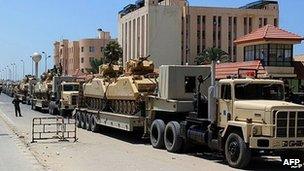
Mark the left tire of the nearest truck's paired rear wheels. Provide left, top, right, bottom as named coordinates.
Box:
left=150, top=119, right=165, bottom=149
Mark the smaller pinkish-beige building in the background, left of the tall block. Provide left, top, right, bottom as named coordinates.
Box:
left=54, top=31, right=113, bottom=75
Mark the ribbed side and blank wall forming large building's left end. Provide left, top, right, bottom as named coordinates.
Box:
left=118, top=5, right=181, bottom=67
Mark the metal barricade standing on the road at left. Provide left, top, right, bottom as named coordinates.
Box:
left=32, top=116, right=77, bottom=143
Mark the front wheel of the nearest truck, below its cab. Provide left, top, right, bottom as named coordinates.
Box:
left=225, top=133, right=251, bottom=169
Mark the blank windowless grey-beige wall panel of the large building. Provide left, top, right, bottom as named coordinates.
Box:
left=147, top=6, right=182, bottom=67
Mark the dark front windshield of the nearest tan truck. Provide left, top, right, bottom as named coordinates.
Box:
left=235, top=83, right=284, bottom=100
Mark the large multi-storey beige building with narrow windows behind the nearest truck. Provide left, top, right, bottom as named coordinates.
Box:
left=118, top=0, right=279, bottom=66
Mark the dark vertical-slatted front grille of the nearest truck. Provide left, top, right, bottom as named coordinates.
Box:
left=274, top=111, right=304, bottom=138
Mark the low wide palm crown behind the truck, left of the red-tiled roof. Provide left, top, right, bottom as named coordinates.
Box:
left=195, top=48, right=230, bottom=65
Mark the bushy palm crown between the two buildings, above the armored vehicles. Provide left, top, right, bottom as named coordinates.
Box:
left=103, top=41, right=123, bottom=64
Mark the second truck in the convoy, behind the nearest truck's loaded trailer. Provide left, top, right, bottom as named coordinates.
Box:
left=49, top=76, right=79, bottom=116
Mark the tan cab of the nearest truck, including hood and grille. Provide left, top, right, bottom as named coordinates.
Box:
left=216, top=79, right=304, bottom=166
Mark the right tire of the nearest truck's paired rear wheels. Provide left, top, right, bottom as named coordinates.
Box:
left=164, top=121, right=183, bottom=153
